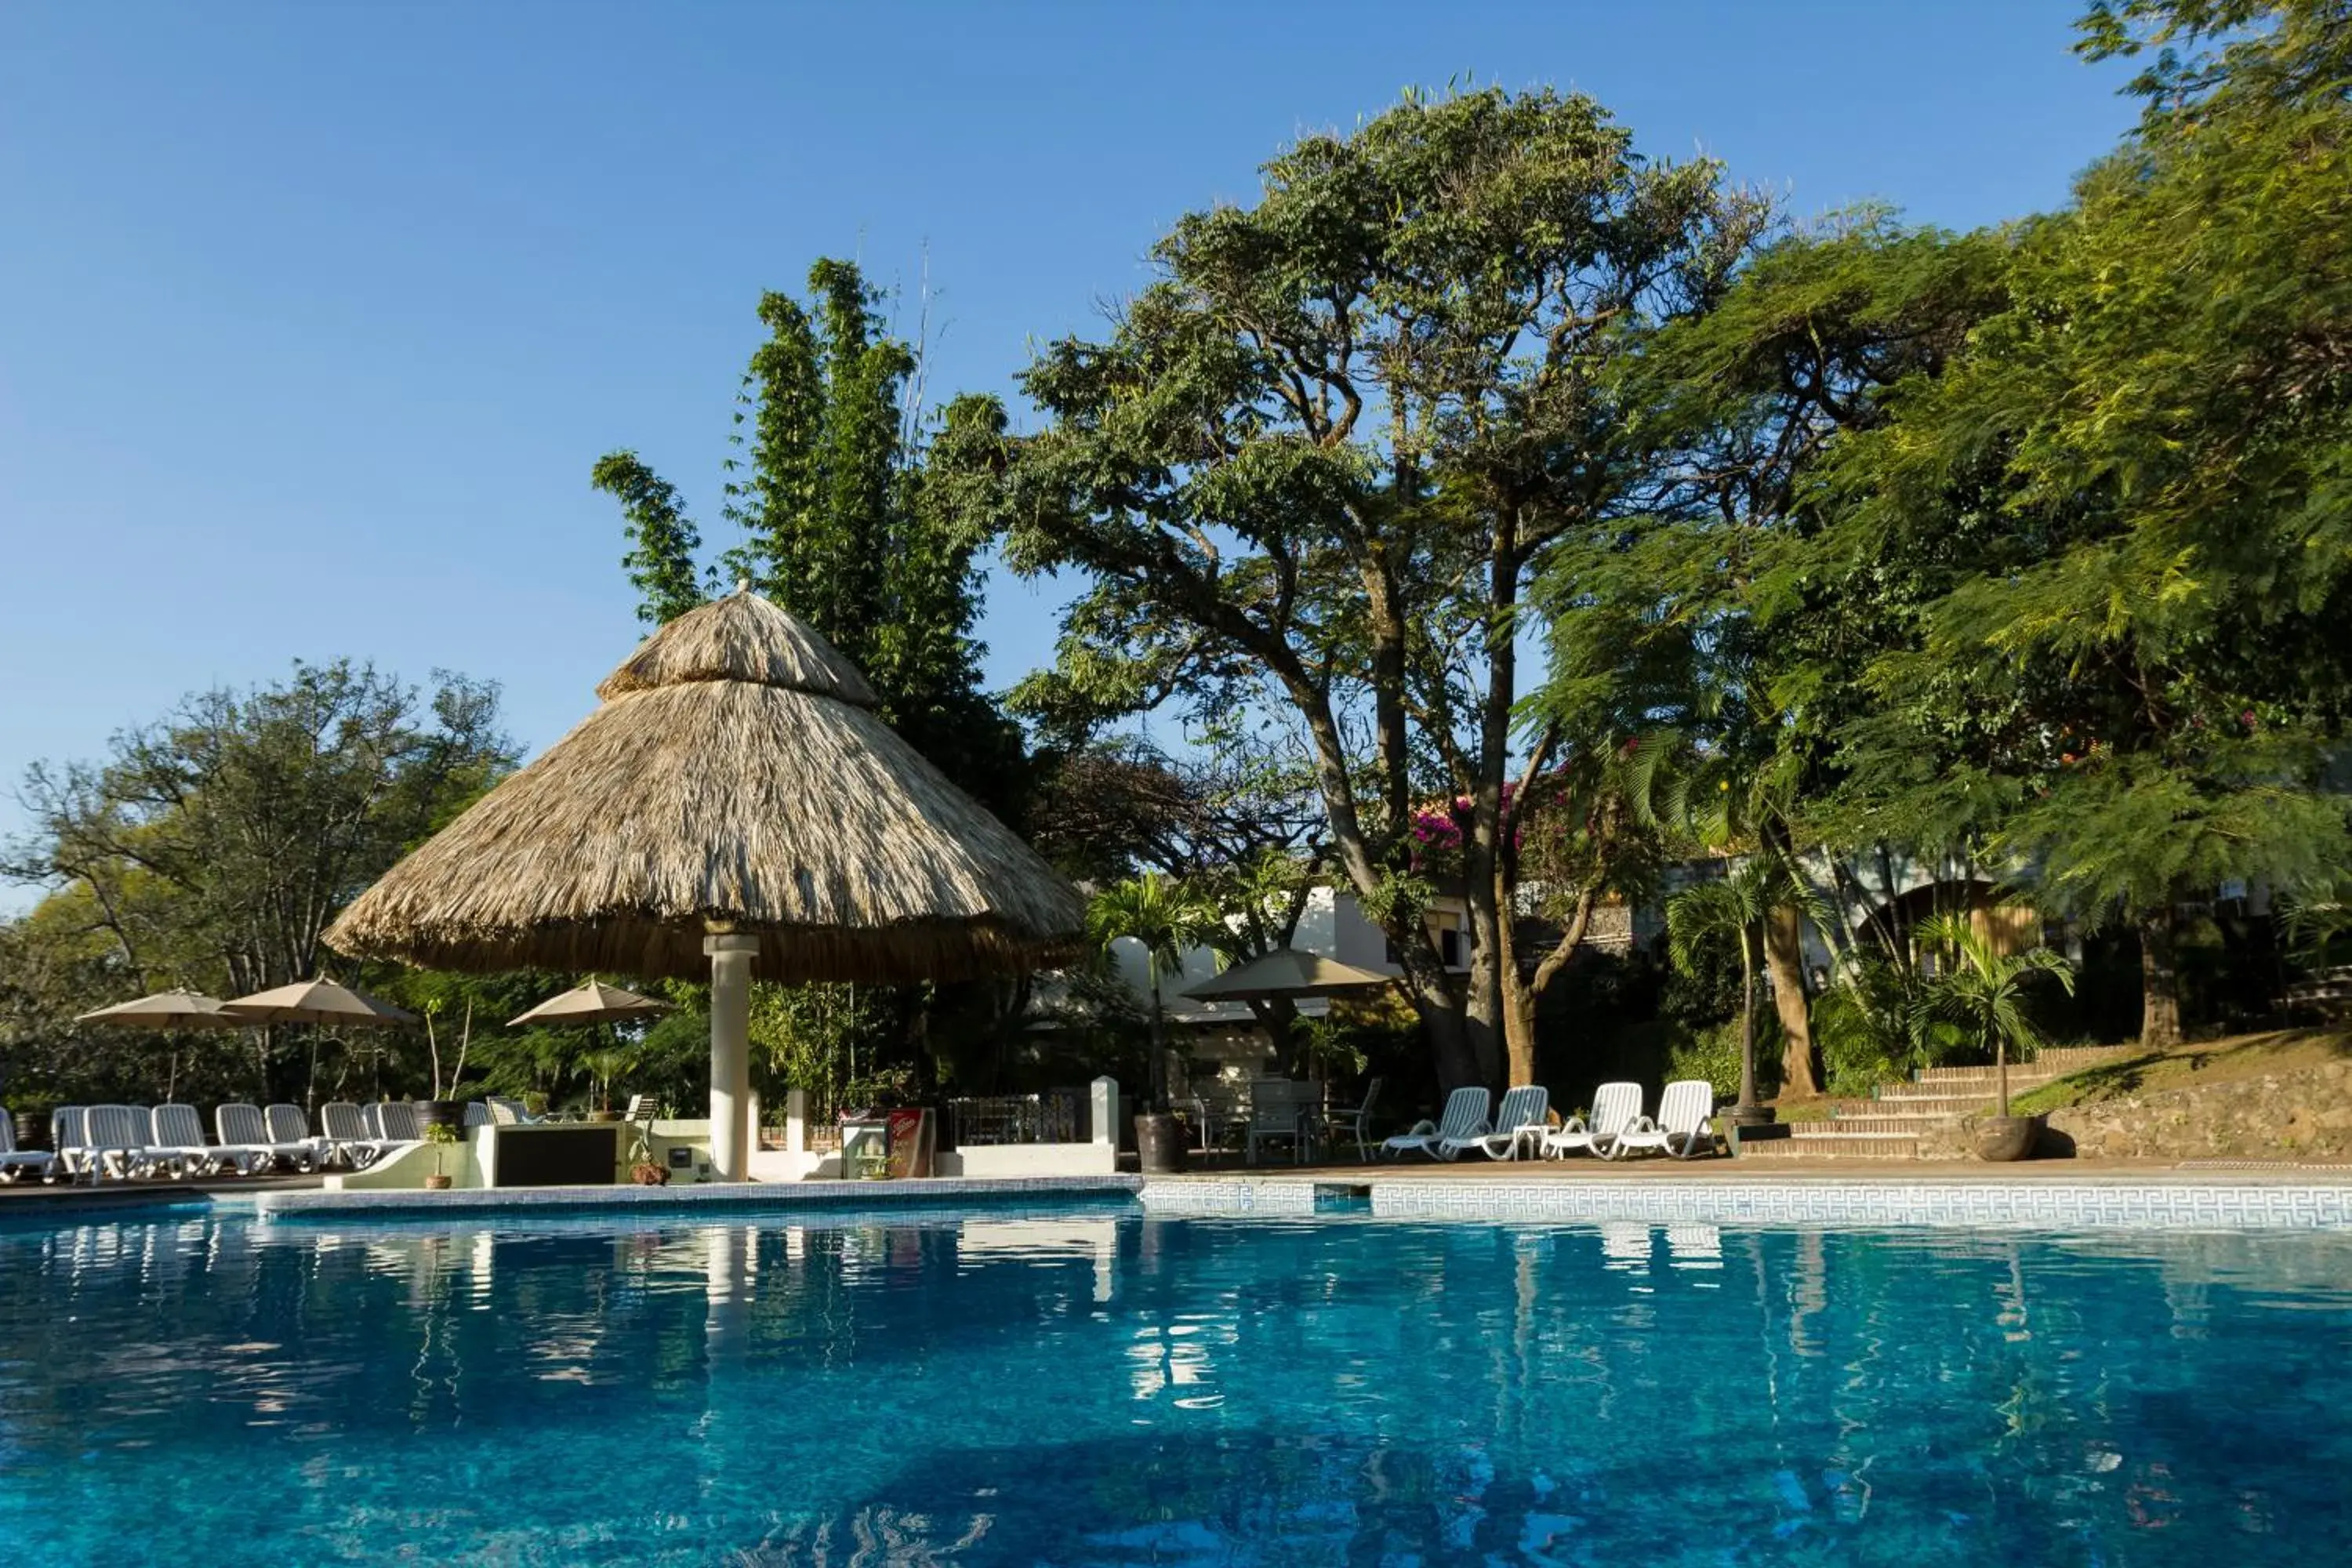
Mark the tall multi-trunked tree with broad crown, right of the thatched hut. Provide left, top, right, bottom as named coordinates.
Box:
left=962, top=92, right=1769, bottom=1083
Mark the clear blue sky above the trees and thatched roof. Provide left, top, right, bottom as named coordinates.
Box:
left=0, top=0, right=2131, bottom=905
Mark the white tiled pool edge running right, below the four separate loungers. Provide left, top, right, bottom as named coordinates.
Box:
left=1138, top=1173, right=2352, bottom=1229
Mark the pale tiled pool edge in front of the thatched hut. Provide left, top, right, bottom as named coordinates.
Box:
left=247, top=1175, right=1143, bottom=1220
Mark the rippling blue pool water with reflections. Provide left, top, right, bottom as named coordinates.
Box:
left=0, top=1208, right=2352, bottom=1568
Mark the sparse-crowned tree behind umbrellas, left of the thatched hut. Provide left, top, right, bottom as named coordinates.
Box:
left=0, top=663, right=515, bottom=1098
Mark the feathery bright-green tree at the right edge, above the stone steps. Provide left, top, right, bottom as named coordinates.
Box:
left=1778, top=5, right=2352, bottom=1044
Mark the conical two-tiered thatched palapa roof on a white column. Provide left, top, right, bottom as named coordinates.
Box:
left=327, top=593, right=1084, bottom=980
